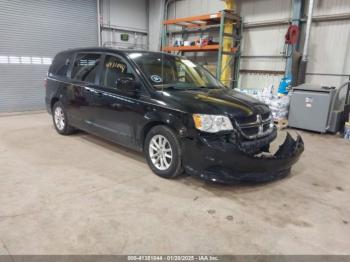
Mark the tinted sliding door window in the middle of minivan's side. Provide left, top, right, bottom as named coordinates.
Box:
left=72, top=54, right=101, bottom=83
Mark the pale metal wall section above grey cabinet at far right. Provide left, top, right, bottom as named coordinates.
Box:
left=306, top=0, right=350, bottom=86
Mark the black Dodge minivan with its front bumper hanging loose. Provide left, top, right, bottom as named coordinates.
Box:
left=45, top=48, right=304, bottom=183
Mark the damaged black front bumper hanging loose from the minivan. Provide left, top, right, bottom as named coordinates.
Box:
left=183, top=133, right=304, bottom=184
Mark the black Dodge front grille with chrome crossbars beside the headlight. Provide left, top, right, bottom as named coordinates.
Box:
left=235, top=112, right=273, bottom=139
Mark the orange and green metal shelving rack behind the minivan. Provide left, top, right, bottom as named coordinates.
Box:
left=162, top=10, right=243, bottom=88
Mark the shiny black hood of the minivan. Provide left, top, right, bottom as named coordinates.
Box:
left=160, top=88, right=270, bottom=117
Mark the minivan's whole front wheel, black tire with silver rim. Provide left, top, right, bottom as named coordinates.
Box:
left=144, top=125, right=183, bottom=178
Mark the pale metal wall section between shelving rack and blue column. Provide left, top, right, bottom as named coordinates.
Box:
left=237, top=0, right=291, bottom=89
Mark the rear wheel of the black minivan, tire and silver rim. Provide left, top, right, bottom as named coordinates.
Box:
left=52, top=101, right=75, bottom=135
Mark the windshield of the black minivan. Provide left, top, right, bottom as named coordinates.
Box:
left=129, top=53, right=223, bottom=90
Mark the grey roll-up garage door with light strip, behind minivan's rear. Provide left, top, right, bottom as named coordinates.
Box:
left=0, top=0, right=98, bottom=112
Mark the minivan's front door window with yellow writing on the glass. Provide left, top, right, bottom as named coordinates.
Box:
left=101, top=55, right=135, bottom=88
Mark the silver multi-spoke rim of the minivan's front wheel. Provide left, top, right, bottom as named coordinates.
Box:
left=149, top=135, right=173, bottom=170
